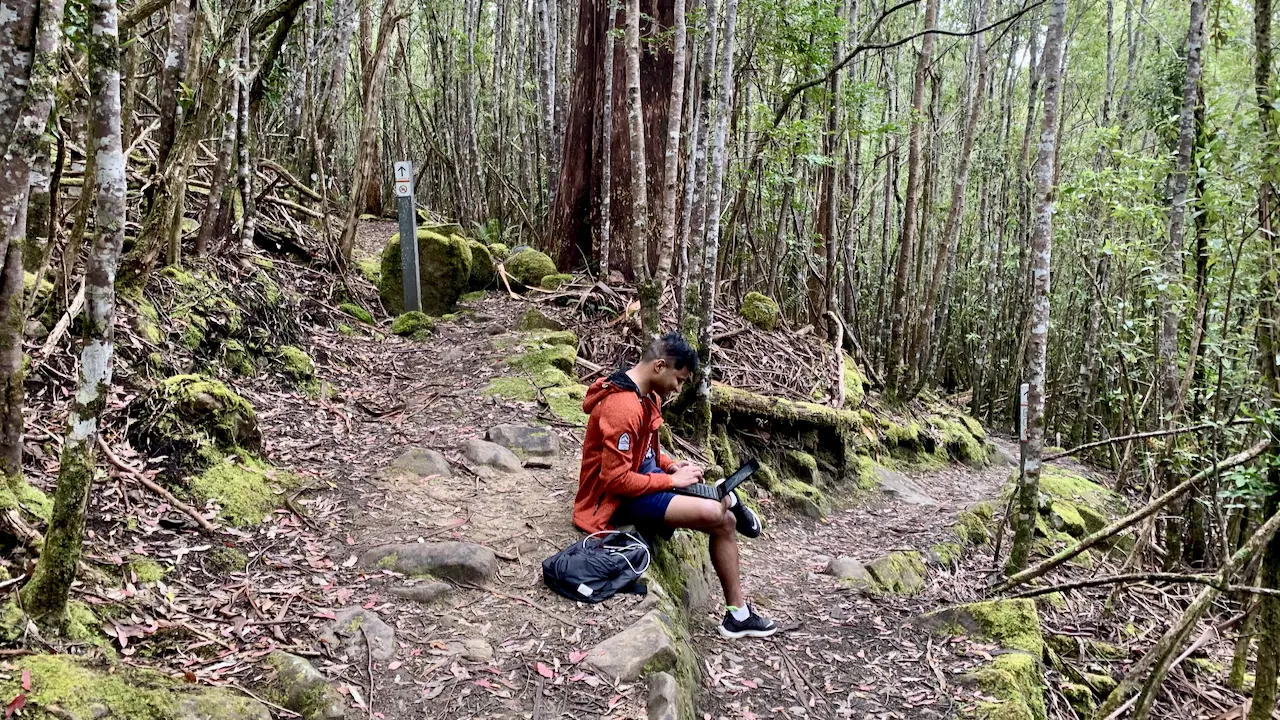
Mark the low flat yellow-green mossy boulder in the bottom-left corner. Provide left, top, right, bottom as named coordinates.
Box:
left=0, top=655, right=271, bottom=720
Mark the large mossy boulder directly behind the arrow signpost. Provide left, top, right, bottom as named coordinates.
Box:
left=378, top=229, right=474, bottom=315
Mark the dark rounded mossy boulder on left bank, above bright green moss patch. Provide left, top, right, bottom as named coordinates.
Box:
left=131, top=375, right=262, bottom=468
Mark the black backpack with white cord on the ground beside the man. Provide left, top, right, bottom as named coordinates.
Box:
left=543, top=530, right=649, bottom=602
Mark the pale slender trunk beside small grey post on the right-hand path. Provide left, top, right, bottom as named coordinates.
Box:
left=1007, top=0, right=1066, bottom=571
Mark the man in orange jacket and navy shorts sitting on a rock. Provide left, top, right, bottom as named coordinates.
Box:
left=573, top=333, right=777, bottom=638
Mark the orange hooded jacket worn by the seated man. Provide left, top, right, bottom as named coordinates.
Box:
left=573, top=370, right=673, bottom=533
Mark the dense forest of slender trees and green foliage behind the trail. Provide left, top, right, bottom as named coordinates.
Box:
left=0, top=0, right=1280, bottom=719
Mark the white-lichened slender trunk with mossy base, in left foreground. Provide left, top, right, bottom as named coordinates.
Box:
left=22, top=0, right=127, bottom=626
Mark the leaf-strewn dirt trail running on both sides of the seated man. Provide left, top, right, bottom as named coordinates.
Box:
left=247, top=221, right=1009, bottom=719
